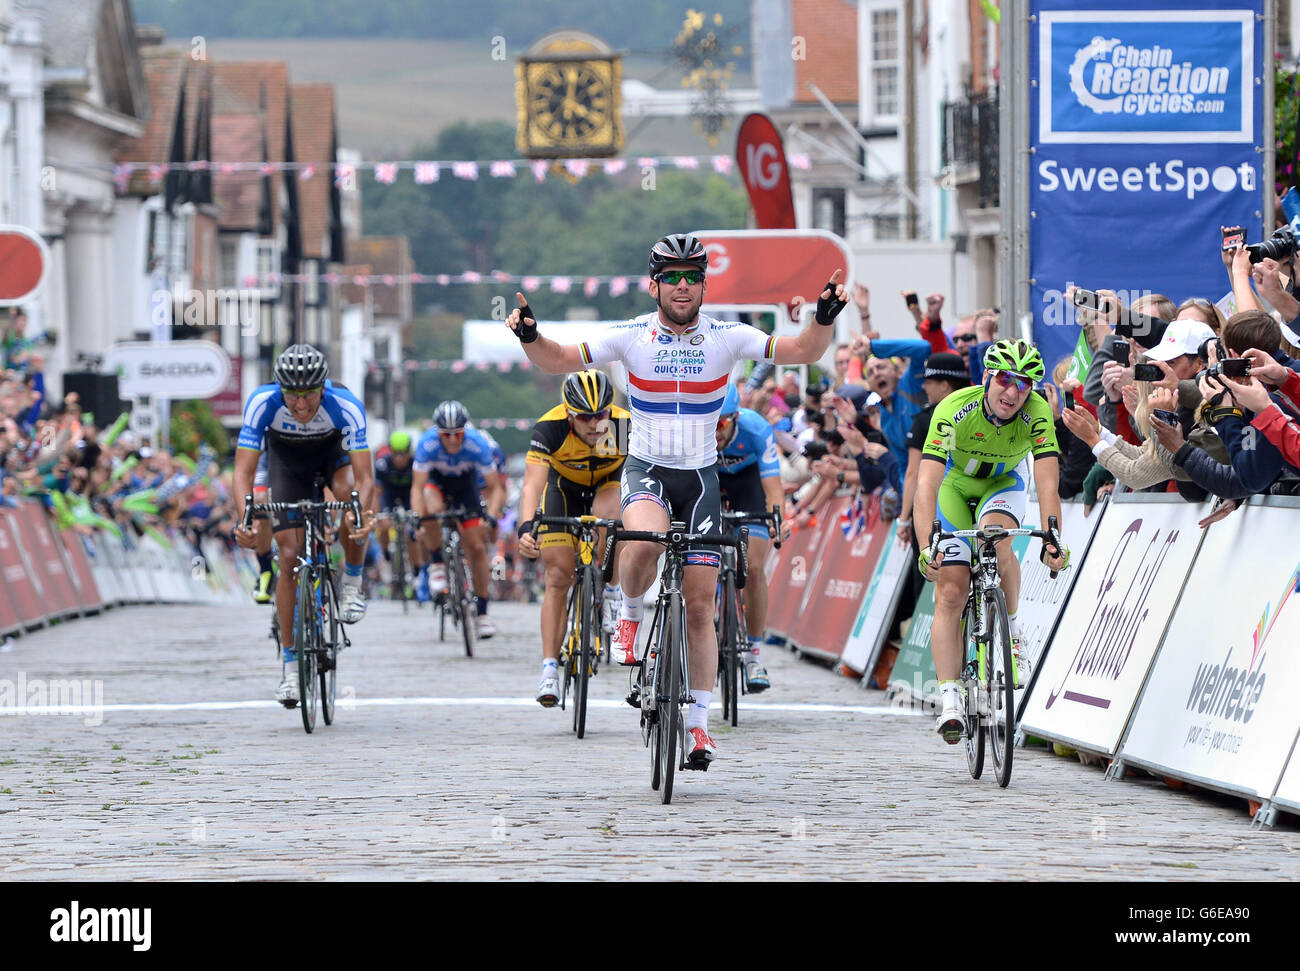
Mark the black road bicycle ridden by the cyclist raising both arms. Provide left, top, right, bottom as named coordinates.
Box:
left=602, top=523, right=749, bottom=805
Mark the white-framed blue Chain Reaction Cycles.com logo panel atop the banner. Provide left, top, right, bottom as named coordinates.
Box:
left=1039, top=10, right=1255, bottom=143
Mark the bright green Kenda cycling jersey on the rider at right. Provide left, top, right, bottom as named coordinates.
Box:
left=920, top=385, right=1060, bottom=478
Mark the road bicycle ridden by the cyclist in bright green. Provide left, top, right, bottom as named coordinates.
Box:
left=930, top=516, right=1061, bottom=789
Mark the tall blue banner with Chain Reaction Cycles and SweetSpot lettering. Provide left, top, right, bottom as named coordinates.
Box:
left=1028, top=0, right=1273, bottom=373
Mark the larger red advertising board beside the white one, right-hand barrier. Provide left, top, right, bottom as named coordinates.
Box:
left=789, top=495, right=891, bottom=660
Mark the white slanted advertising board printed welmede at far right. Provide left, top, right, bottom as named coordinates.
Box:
left=1117, top=497, right=1300, bottom=802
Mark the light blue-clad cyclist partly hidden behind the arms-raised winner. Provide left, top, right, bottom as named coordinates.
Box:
left=718, top=385, right=785, bottom=694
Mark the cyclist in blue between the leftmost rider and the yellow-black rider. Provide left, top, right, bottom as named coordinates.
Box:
left=411, top=400, right=506, bottom=640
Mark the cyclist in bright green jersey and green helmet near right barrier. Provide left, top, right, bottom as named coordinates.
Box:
left=913, top=341, right=1070, bottom=745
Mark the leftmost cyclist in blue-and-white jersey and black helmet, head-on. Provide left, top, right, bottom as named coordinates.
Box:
left=234, top=344, right=374, bottom=708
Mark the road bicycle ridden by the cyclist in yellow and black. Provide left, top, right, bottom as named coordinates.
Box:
left=532, top=516, right=620, bottom=738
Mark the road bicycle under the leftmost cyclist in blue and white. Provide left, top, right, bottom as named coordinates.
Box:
left=243, top=477, right=361, bottom=734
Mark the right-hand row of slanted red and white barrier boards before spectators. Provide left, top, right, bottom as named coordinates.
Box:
left=768, top=490, right=1300, bottom=825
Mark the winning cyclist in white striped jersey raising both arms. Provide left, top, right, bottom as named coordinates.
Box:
left=506, top=234, right=848, bottom=768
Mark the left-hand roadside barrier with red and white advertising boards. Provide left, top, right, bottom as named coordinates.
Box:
left=0, top=499, right=256, bottom=636
